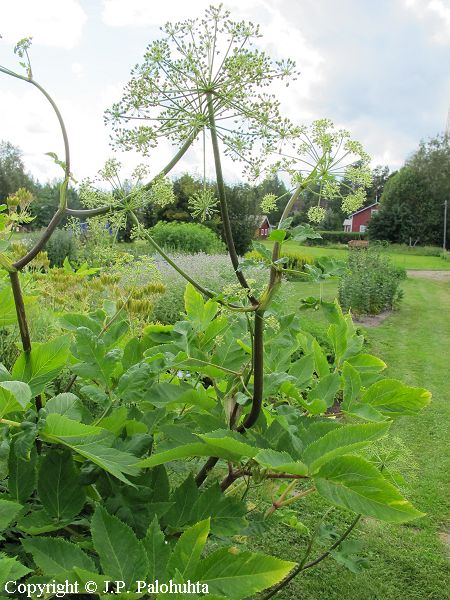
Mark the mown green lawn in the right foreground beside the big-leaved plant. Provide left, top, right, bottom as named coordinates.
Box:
left=251, top=279, right=450, bottom=600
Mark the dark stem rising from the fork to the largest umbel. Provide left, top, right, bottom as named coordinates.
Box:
left=208, top=94, right=258, bottom=306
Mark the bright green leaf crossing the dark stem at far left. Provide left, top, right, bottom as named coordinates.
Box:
left=12, top=336, right=70, bottom=396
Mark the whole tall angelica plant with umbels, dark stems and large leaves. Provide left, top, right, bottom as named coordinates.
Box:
left=0, top=7, right=430, bottom=600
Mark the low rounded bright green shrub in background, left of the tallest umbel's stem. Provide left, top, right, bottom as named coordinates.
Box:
left=150, top=221, right=225, bottom=254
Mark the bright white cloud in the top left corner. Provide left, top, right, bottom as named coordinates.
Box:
left=0, top=0, right=87, bottom=49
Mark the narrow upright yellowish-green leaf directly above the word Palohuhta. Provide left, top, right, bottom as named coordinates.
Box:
left=167, top=519, right=210, bottom=577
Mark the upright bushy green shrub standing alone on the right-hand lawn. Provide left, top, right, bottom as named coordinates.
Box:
left=339, top=249, right=406, bottom=315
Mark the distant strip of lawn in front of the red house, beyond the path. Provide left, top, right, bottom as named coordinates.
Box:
left=266, top=242, right=450, bottom=271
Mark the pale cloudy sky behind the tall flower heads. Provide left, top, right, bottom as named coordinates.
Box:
left=0, top=0, right=450, bottom=181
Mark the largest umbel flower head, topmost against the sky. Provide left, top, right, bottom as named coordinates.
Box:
left=105, top=5, right=296, bottom=172
